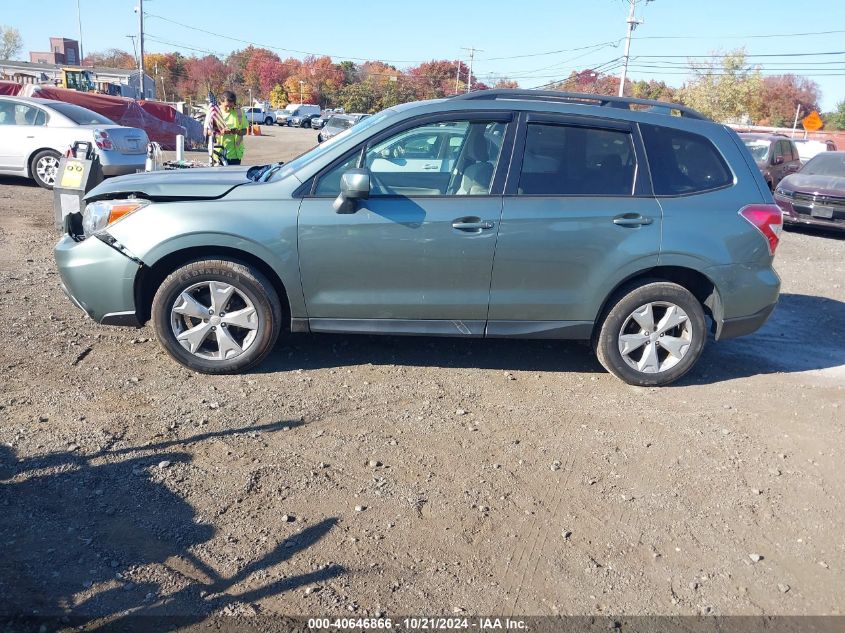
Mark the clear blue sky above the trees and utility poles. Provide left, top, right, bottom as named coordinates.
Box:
left=6, top=0, right=845, bottom=110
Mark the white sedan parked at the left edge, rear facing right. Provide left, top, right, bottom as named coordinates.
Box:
left=0, top=97, right=149, bottom=189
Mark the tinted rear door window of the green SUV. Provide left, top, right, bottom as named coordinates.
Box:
left=518, top=123, right=636, bottom=196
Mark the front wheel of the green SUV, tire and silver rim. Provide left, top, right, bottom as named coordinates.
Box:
left=152, top=259, right=282, bottom=374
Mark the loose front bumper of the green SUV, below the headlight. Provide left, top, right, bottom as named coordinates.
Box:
left=53, top=235, right=140, bottom=326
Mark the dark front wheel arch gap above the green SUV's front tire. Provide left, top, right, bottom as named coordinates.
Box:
left=134, top=245, right=291, bottom=326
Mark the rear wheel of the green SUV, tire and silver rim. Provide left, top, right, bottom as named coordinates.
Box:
left=595, top=280, right=707, bottom=387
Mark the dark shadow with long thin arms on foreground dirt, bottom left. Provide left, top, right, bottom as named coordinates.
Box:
left=0, top=421, right=345, bottom=631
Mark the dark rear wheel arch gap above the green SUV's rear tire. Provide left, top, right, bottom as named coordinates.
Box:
left=593, top=266, right=724, bottom=340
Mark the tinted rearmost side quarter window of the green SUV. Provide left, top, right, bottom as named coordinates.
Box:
left=640, top=124, right=733, bottom=196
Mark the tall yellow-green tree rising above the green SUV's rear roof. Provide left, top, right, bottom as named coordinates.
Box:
left=680, top=49, right=763, bottom=123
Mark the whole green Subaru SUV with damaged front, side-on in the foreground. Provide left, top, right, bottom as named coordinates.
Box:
left=56, top=90, right=782, bottom=385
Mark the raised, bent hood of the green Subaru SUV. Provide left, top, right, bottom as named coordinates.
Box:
left=85, top=166, right=252, bottom=202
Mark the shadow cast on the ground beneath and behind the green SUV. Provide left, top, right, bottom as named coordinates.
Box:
left=254, top=294, right=845, bottom=384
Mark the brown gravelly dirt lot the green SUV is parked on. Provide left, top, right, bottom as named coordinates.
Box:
left=0, top=128, right=845, bottom=620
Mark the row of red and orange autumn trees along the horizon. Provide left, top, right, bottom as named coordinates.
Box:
left=8, top=34, right=845, bottom=130
